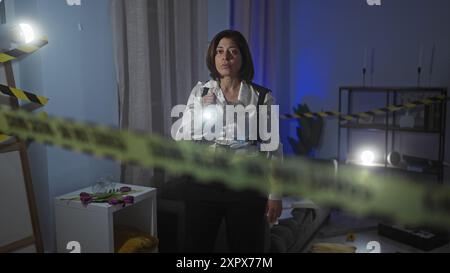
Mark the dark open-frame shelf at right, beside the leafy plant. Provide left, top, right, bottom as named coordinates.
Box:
left=337, top=86, right=448, bottom=183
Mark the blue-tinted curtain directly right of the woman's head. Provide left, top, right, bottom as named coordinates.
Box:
left=230, top=0, right=293, bottom=154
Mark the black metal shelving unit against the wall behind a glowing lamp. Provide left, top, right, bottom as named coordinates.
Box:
left=337, top=86, right=448, bottom=183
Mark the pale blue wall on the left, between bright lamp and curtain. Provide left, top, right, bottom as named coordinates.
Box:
left=15, top=0, right=119, bottom=251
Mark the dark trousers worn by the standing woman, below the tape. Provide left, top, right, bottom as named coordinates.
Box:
left=185, top=180, right=267, bottom=253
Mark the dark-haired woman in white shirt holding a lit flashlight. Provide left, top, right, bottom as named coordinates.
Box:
left=179, top=30, right=282, bottom=252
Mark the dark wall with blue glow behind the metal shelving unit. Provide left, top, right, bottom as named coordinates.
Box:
left=289, top=0, right=450, bottom=163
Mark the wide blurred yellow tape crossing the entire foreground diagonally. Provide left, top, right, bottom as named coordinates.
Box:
left=0, top=107, right=450, bottom=228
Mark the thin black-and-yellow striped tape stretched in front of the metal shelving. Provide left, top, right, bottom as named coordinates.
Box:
left=280, top=95, right=449, bottom=121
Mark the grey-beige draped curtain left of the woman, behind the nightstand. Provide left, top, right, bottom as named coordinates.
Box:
left=112, top=0, right=208, bottom=186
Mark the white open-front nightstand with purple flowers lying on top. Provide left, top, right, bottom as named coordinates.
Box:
left=55, top=184, right=157, bottom=253
